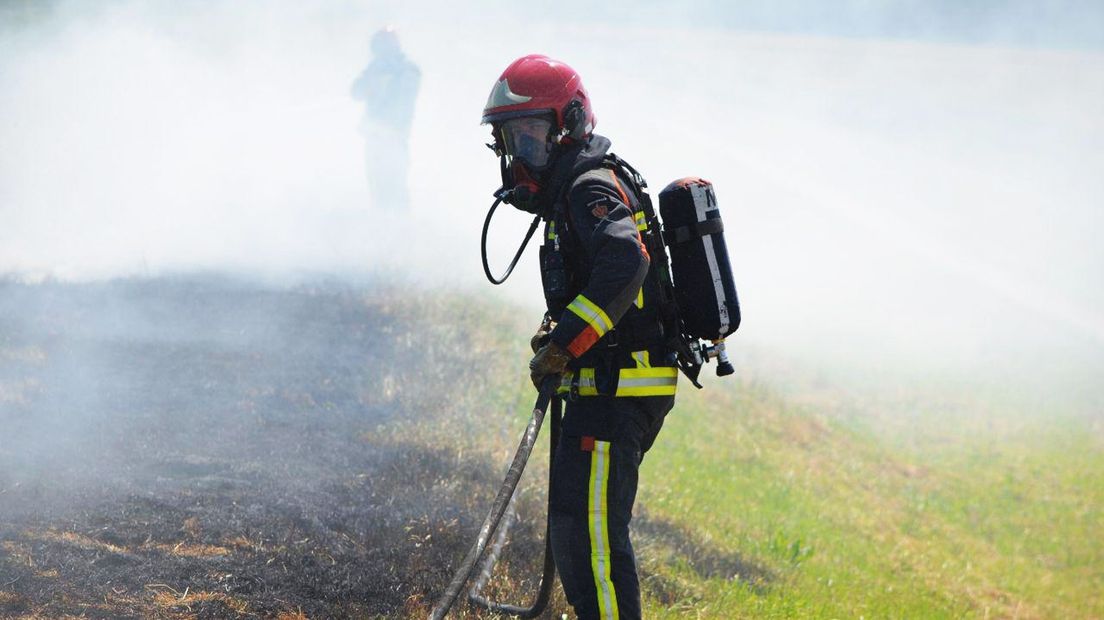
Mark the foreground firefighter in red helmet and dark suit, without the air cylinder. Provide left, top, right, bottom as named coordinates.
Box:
left=482, top=55, right=677, bottom=619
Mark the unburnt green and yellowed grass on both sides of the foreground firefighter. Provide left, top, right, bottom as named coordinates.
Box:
left=399, top=301, right=1104, bottom=619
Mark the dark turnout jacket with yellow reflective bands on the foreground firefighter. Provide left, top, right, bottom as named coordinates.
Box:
left=541, top=136, right=677, bottom=396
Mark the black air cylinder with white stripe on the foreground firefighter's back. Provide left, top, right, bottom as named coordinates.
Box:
left=659, top=177, right=740, bottom=341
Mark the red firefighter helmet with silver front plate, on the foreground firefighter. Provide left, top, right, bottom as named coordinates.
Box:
left=482, top=54, right=597, bottom=139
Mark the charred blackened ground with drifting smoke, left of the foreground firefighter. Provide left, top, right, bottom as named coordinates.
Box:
left=0, top=276, right=768, bottom=618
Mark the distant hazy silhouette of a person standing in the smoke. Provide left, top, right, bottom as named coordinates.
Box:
left=352, top=26, right=422, bottom=210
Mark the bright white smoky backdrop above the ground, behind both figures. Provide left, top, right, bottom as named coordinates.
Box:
left=0, top=0, right=1104, bottom=381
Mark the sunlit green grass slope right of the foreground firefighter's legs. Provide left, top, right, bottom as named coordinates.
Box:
left=638, top=370, right=1104, bottom=618
